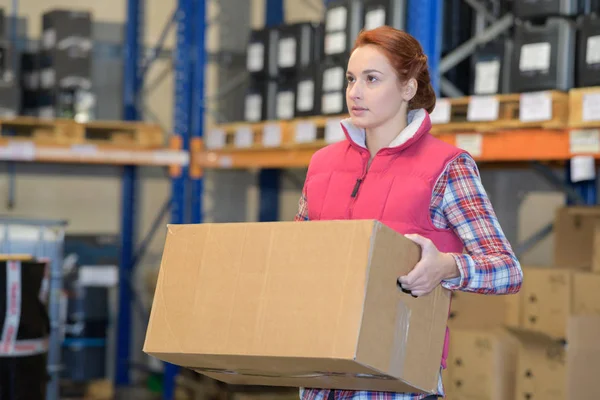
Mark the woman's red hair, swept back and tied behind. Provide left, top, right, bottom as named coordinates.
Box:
left=352, top=26, right=436, bottom=113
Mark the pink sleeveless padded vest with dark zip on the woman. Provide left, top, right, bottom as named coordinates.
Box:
left=305, top=114, right=464, bottom=368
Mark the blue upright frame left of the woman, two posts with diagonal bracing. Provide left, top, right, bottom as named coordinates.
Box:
left=115, top=0, right=206, bottom=399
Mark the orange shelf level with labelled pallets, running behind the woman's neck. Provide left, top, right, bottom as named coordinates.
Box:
left=198, top=88, right=600, bottom=169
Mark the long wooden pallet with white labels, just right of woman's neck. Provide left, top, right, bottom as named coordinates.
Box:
left=431, top=91, right=569, bottom=133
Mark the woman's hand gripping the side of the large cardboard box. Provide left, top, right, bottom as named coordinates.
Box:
left=398, top=234, right=460, bottom=297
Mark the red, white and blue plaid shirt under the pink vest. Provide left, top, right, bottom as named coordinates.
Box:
left=295, top=154, right=523, bottom=400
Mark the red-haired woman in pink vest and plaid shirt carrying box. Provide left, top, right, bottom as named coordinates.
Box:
left=296, top=27, right=523, bottom=400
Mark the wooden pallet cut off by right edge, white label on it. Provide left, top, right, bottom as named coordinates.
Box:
left=569, top=86, right=600, bottom=128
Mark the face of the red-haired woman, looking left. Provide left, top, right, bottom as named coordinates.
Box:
left=346, top=45, right=414, bottom=129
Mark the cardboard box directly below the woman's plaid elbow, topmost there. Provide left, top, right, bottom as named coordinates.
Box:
left=448, top=291, right=516, bottom=331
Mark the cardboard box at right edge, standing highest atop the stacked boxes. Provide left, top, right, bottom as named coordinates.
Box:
left=554, top=206, right=600, bottom=273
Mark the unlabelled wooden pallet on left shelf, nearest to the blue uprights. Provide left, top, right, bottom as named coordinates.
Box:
left=74, top=121, right=165, bottom=149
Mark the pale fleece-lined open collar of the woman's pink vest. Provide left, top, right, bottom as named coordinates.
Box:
left=341, top=109, right=431, bottom=152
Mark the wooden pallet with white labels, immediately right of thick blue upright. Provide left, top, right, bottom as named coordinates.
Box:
left=205, top=121, right=292, bottom=150
